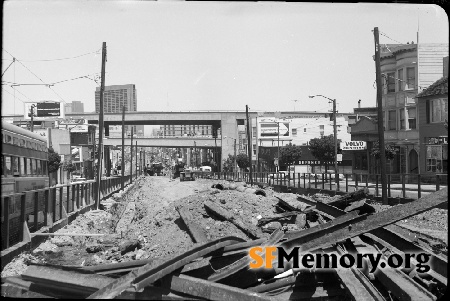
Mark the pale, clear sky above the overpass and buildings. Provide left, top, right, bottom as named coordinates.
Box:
left=1, top=0, right=449, bottom=116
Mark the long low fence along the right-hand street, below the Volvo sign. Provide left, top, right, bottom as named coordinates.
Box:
left=195, top=172, right=448, bottom=199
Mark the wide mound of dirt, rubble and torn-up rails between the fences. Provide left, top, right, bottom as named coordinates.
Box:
left=2, top=177, right=447, bottom=300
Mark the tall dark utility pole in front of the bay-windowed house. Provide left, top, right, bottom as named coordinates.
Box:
left=373, top=27, right=388, bottom=205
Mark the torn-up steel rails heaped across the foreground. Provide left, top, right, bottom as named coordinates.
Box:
left=2, top=188, right=447, bottom=300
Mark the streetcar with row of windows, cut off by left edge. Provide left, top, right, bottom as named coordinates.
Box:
left=1, top=120, right=49, bottom=196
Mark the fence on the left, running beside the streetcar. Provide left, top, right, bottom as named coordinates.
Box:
left=1, top=175, right=136, bottom=251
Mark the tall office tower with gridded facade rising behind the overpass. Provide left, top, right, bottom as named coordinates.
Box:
left=95, top=84, right=144, bottom=136
